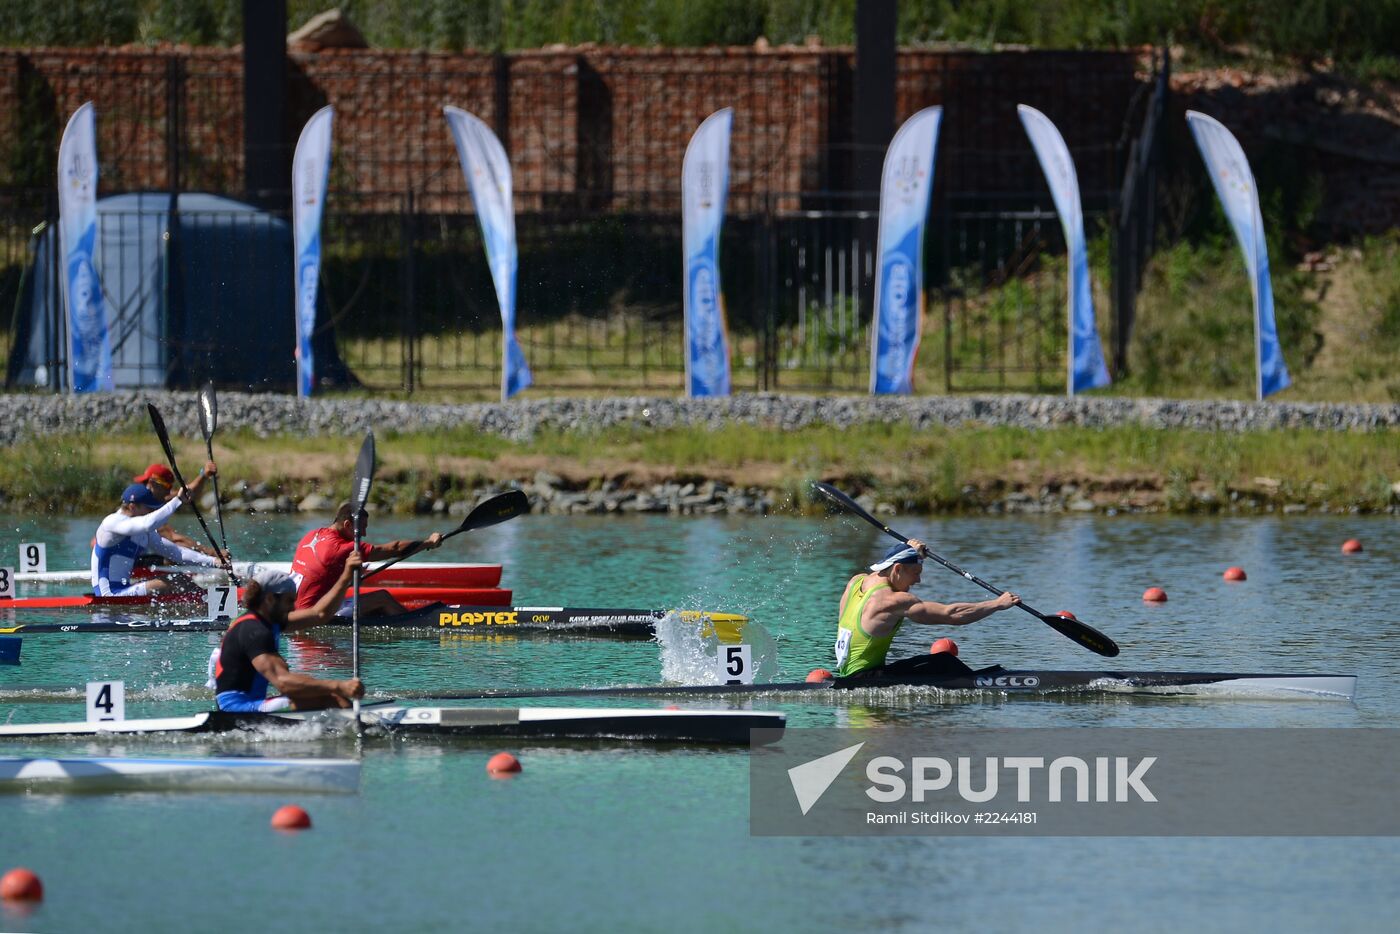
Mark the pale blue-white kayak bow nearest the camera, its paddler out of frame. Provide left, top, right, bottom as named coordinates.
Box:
left=0, top=756, right=360, bottom=793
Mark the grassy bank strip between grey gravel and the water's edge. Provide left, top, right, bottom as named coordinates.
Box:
left=0, top=426, right=1400, bottom=513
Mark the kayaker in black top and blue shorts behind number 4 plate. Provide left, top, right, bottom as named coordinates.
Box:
left=210, top=562, right=364, bottom=713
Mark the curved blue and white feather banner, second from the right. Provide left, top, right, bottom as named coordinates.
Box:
left=1016, top=104, right=1110, bottom=396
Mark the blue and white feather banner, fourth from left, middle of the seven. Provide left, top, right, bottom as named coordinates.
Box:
left=680, top=106, right=734, bottom=396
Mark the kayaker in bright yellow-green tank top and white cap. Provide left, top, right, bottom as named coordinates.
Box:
left=836, top=538, right=1021, bottom=678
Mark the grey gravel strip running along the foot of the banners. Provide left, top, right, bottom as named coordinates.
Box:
left=0, top=392, right=1400, bottom=444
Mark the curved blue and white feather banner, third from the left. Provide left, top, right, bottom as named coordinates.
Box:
left=442, top=106, right=532, bottom=402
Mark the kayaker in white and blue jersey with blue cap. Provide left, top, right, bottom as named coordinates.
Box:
left=92, top=483, right=228, bottom=597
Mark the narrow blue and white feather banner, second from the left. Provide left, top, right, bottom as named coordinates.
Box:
left=291, top=106, right=335, bottom=396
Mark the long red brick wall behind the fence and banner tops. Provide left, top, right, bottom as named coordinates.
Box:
left=0, top=48, right=1138, bottom=210
